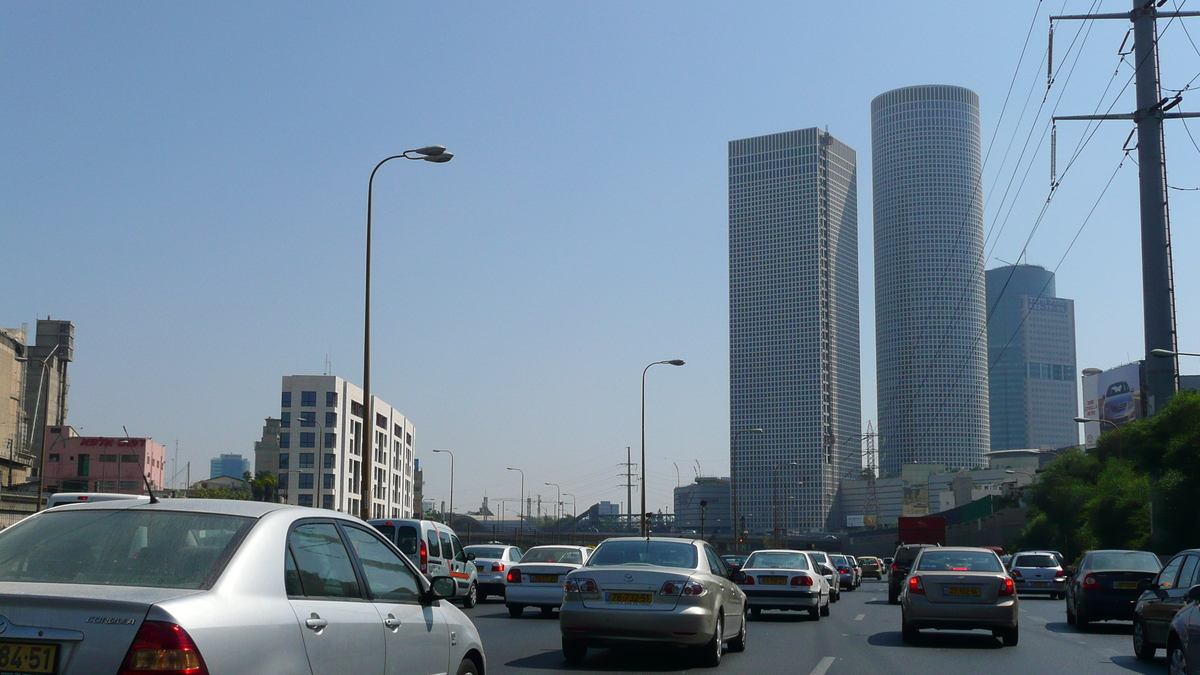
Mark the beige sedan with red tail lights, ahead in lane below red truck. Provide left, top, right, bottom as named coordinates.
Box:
left=900, top=546, right=1018, bottom=646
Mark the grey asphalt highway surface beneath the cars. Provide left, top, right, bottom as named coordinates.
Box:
left=467, top=581, right=1166, bottom=675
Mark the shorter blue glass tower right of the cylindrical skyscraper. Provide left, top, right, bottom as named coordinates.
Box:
left=986, top=264, right=1079, bottom=450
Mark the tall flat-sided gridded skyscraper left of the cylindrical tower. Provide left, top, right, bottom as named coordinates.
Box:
left=730, top=129, right=862, bottom=532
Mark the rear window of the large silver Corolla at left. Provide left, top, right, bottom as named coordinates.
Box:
left=0, top=508, right=254, bottom=589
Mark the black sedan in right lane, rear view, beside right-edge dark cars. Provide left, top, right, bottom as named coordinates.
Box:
left=1067, top=542, right=1163, bottom=631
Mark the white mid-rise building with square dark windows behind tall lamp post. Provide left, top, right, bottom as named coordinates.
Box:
left=270, top=375, right=416, bottom=518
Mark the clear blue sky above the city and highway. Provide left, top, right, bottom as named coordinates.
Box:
left=0, top=0, right=1200, bottom=510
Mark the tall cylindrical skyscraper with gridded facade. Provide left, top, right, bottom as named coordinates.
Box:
left=871, top=85, right=991, bottom=473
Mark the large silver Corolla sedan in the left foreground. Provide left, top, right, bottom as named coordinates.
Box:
left=0, top=500, right=485, bottom=675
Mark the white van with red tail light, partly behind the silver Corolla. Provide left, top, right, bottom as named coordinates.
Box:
left=367, top=518, right=479, bottom=608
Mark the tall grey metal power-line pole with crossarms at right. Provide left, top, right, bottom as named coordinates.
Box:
left=1046, top=0, right=1200, bottom=416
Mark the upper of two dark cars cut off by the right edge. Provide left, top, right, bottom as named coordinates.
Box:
left=1133, top=549, right=1200, bottom=661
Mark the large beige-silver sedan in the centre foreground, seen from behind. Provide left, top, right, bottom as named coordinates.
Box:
left=556, top=537, right=746, bottom=667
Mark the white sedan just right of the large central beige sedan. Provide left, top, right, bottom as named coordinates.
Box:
left=739, top=549, right=829, bottom=621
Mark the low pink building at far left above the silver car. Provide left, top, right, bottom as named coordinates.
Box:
left=43, top=426, right=167, bottom=495
